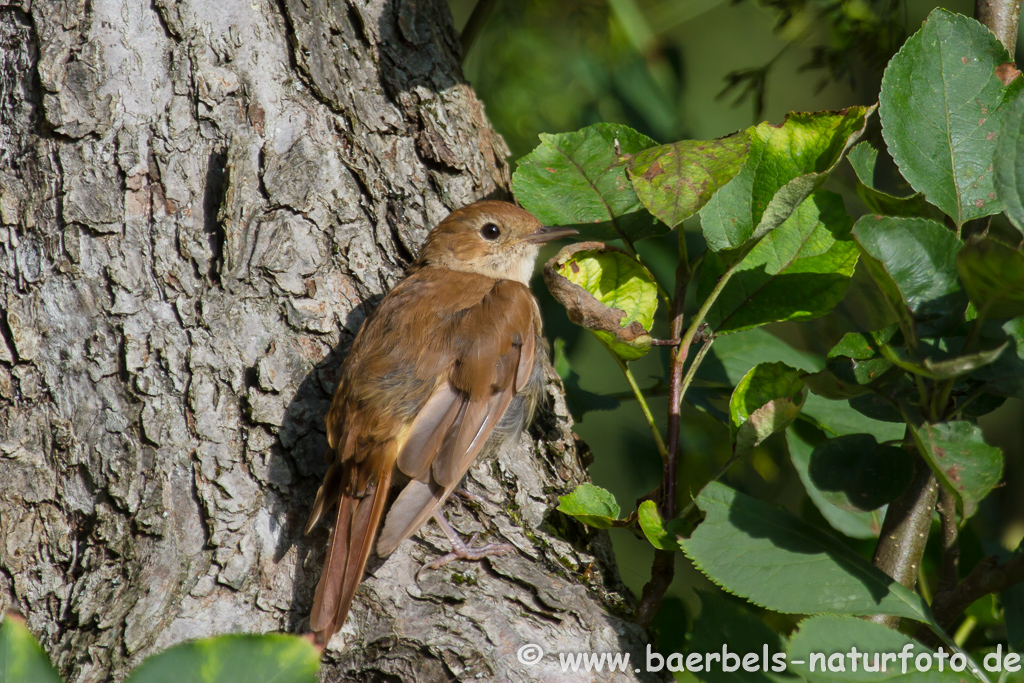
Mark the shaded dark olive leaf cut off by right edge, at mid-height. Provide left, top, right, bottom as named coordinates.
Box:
left=956, top=238, right=1024, bottom=319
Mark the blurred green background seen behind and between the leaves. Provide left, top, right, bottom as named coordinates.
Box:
left=450, top=0, right=1024, bottom=663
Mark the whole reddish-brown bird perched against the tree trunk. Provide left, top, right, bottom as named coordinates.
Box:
left=306, top=201, right=575, bottom=642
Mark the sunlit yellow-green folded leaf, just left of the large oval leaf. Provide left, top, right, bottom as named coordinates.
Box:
left=700, top=106, right=874, bottom=251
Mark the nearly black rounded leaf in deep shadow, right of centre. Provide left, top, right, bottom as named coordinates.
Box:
left=808, top=434, right=913, bottom=511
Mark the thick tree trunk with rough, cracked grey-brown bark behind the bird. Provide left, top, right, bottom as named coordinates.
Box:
left=0, top=0, right=645, bottom=681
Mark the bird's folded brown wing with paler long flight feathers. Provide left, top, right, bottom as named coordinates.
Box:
left=377, top=281, right=537, bottom=557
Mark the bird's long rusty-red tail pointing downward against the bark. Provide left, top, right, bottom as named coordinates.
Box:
left=309, top=462, right=391, bottom=643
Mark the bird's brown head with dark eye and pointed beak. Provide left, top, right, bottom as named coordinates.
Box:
left=417, top=201, right=577, bottom=286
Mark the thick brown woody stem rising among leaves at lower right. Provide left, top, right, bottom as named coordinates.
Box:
left=871, top=444, right=939, bottom=629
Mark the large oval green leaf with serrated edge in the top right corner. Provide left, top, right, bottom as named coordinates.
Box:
left=879, top=9, right=1021, bottom=225
